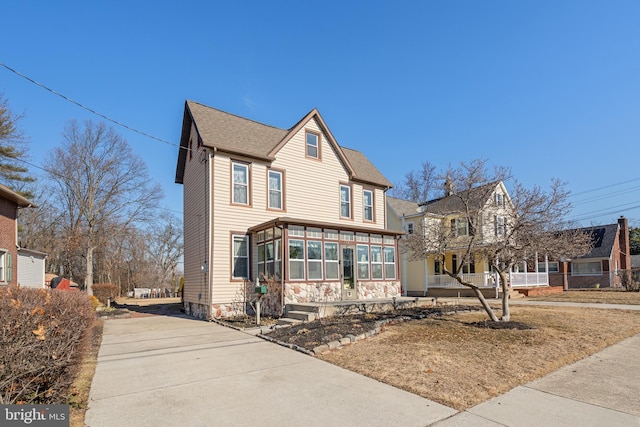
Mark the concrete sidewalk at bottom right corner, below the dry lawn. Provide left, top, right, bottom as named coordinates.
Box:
left=435, top=335, right=640, bottom=427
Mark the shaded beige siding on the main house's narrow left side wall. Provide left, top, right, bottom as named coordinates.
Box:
left=183, top=126, right=210, bottom=304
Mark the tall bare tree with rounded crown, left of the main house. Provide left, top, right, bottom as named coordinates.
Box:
left=46, top=121, right=162, bottom=295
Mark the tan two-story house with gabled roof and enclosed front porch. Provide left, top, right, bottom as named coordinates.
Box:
left=176, top=101, right=402, bottom=318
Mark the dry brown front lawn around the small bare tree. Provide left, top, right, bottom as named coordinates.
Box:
left=320, top=306, right=640, bottom=410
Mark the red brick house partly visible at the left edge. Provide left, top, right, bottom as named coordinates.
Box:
left=0, top=184, right=35, bottom=286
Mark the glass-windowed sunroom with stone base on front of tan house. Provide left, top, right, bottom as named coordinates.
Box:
left=249, top=218, right=403, bottom=307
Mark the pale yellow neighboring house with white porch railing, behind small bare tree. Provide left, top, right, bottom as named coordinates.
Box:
left=387, top=182, right=549, bottom=296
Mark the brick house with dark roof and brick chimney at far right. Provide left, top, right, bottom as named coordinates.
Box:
left=549, top=216, right=631, bottom=289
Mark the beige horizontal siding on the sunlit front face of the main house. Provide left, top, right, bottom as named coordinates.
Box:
left=209, top=120, right=385, bottom=304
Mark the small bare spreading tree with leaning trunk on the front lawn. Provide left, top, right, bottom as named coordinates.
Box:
left=403, top=160, right=591, bottom=321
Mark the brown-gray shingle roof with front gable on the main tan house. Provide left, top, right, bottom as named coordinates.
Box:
left=176, top=101, right=392, bottom=188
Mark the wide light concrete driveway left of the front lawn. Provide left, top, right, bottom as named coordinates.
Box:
left=85, top=316, right=456, bottom=427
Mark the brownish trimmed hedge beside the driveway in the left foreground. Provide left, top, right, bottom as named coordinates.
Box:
left=0, top=287, right=95, bottom=404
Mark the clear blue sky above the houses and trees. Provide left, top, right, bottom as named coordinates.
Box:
left=0, top=0, right=640, bottom=225
